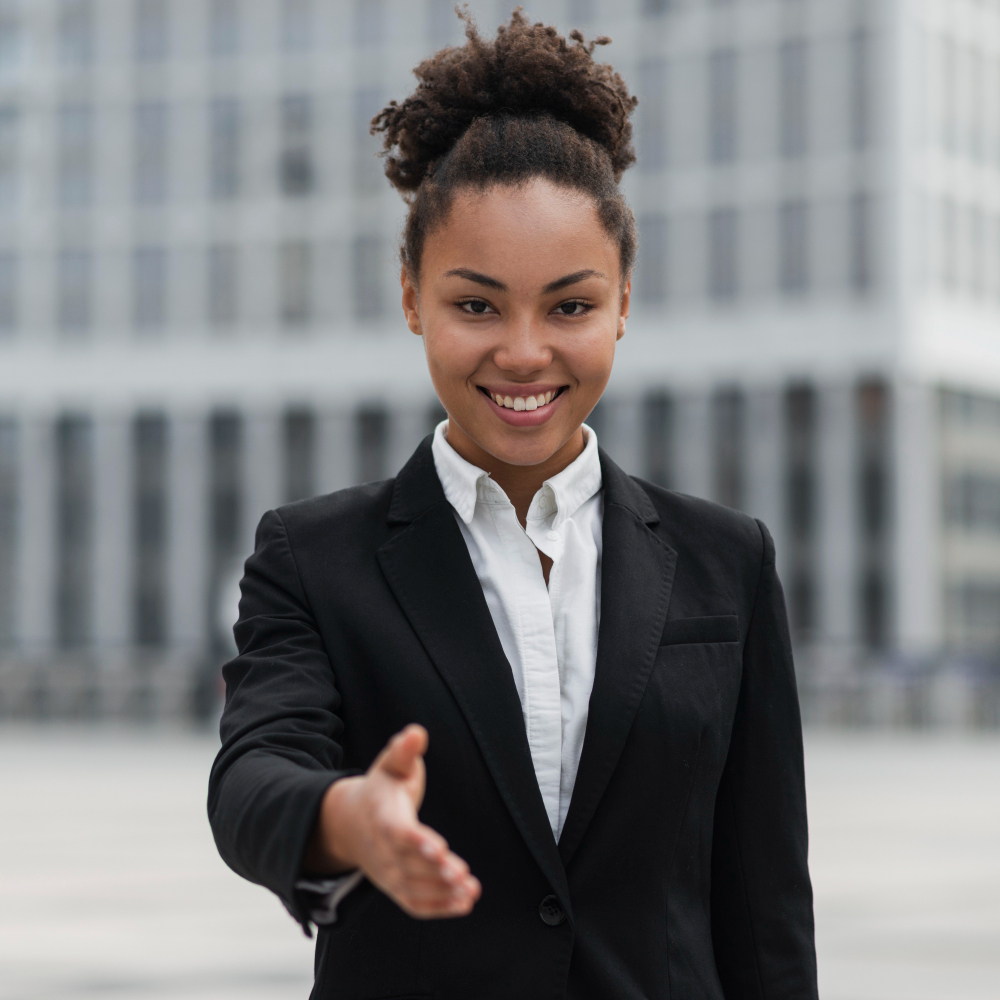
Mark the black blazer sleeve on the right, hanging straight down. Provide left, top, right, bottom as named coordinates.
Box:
left=712, top=521, right=817, bottom=1000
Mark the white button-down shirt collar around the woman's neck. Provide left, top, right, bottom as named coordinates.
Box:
left=431, top=420, right=601, bottom=527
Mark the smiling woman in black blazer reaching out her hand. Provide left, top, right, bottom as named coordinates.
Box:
left=209, top=14, right=816, bottom=1000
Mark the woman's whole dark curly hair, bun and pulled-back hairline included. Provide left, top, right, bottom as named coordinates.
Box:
left=371, top=7, right=638, bottom=282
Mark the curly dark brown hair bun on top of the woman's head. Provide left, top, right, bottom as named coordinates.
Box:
left=372, top=7, right=638, bottom=193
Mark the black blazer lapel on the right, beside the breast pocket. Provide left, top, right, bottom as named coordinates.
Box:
left=559, top=451, right=677, bottom=866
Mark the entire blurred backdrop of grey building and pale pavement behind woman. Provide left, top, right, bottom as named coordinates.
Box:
left=0, top=0, right=1000, bottom=1000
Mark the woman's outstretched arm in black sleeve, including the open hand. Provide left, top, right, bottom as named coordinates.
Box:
left=208, top=511, right=479, bottom=926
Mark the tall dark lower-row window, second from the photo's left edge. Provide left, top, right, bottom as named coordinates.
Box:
left=55, top=414, right=94, bottom=649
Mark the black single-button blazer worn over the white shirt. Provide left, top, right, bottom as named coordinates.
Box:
left=208, top=439, right=816, bottom=1000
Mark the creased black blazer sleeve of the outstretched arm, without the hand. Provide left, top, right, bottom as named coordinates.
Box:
left=208, top=511, right=357, bottom=933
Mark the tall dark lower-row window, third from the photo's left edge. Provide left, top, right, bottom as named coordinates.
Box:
left=132, top=413, right=168, bottom=646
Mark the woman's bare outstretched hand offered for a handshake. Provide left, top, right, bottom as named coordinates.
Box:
left=306, top=725, right=482, bottom=918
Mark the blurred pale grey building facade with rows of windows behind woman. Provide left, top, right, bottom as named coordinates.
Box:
left=0, top=0, right=1000, bottom=721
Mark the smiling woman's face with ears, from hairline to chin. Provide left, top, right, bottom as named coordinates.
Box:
left=403, top=179, right=629, bottom=466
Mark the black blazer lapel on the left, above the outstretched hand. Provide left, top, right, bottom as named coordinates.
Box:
left=378, top=439, right=572, bottom=914
